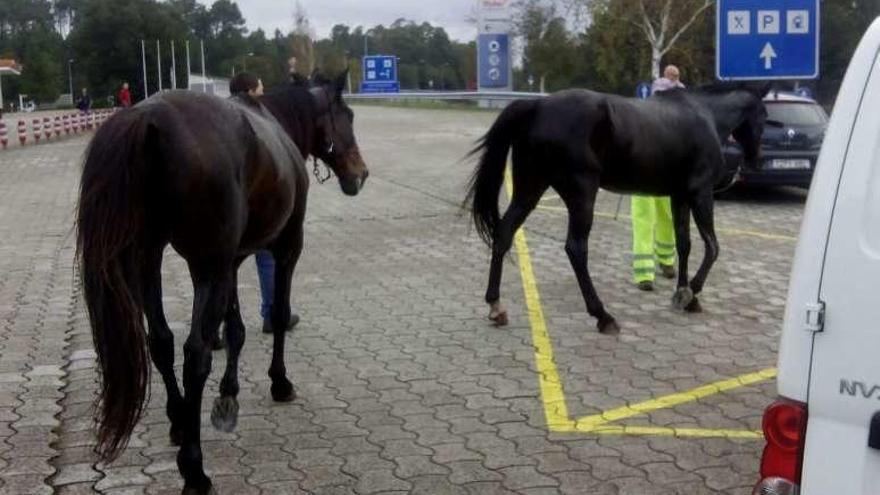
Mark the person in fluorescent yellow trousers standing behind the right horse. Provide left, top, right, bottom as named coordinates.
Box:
left=631, top=65, right=684, bottom=291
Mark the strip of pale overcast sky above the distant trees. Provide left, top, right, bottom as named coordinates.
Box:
left=217, top=0, right=477, bottom=41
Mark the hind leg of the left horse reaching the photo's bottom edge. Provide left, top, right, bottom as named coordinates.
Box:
left=177, top=272, right=232, bottom=495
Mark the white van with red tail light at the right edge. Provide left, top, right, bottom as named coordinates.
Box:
left=753, top=19, right=880, bottom=495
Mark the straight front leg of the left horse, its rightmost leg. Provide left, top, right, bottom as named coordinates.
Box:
left=269, top=220, right=303, bottom=402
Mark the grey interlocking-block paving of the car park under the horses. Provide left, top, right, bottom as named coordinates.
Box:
left=0, top=106, right=804, bottom=495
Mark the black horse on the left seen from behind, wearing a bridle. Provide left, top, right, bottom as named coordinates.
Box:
left=77, top=74, right=367, bottom=494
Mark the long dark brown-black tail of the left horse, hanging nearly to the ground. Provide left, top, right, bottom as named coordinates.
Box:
left=76, top=108, right=150, bottom=460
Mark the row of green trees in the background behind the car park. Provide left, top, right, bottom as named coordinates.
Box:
left=0, top=0, right=880, bottom=108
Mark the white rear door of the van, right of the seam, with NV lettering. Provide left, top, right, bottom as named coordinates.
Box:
left=804, top=29, right=880, bottom=495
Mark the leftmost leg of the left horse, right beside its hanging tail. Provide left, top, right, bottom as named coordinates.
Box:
left=143, top=247, right=184, bottom=446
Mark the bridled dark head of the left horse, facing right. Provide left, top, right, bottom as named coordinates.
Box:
left=309, top=70, right=369, bottom=196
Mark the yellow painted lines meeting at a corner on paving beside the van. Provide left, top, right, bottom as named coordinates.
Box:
left=504, top=169, right=776, bottom=439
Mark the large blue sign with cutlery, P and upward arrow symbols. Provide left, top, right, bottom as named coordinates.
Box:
left=715, top=0, right=819, bottom=80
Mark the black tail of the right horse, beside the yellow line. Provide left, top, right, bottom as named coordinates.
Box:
left=465, top=100, right=538, bottom=246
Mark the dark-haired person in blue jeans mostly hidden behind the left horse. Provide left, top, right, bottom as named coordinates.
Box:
left=229, top=72, right=299, bottom=333
